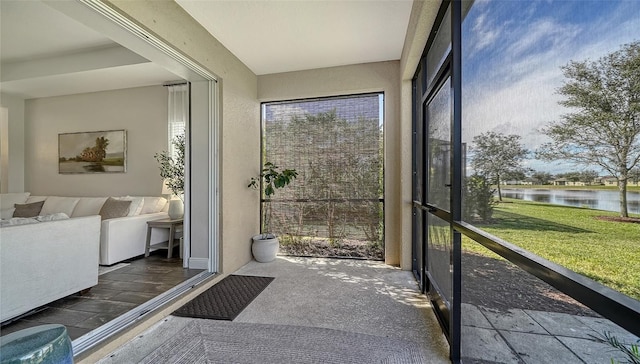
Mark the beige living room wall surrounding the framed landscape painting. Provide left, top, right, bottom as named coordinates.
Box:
left=24, top=86, right=168, bottom=196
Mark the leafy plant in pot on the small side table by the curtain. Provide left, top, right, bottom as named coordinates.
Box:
left=154, top=135, right=185, bottom=220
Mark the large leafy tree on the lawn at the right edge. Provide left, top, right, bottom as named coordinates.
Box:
left=537, top=41, right=640, bottom=217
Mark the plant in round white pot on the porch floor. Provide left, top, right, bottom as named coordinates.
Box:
left=247, top=162, right=298, bottom=263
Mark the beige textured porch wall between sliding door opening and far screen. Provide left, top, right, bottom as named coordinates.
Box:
left=108, top=0, right=260, bottom=273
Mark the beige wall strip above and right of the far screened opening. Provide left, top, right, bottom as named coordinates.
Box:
left=258, top=61, right=400, bottom=269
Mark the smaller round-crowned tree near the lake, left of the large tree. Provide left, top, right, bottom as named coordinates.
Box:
left=471, top=131, right=529, bottom=201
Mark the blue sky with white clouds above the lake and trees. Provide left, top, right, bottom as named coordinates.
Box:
left=462, top=0, right=640, bottom=173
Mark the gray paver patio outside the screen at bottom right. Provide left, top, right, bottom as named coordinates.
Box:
left=462, top=304, right=640, bottom=364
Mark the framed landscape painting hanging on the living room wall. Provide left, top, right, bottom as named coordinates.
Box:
left=58, top=130, right=127, bottom=174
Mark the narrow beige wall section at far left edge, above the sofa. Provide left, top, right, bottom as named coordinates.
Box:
left=0, top=93, right=25, bottom=192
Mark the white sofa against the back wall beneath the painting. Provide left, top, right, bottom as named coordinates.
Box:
left=0, top=192, right=169, bottom=265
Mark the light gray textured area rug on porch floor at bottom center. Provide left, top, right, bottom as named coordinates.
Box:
left=141, top=320, right=426, bottom=364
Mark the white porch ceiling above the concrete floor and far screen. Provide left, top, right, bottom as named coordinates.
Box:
left=176, top=0, right=413, bottom=75
